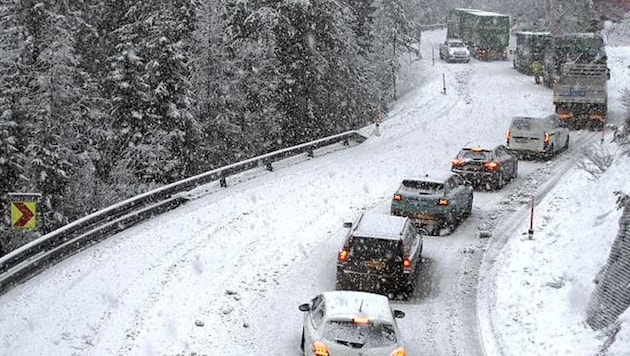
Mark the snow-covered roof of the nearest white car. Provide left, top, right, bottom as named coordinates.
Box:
left=322, top=291, right=394, bottom=322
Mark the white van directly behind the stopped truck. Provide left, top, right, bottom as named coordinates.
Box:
left=506, top=114, right=569, bottom=157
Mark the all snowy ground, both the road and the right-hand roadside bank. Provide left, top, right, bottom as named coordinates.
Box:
left=0, top=31, right=630, bottom=355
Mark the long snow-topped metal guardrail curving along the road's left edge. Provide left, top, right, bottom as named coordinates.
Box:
left=0, top=131, right=367, bottom=295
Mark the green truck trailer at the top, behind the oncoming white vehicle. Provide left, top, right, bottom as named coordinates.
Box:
left=446, top=8, right=510, bottom=61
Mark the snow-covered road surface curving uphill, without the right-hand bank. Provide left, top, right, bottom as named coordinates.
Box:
left=0, top=31, right=612, bottom=356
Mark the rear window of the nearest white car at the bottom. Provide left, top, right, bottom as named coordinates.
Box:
left=323, top=320, right=397, bottom=349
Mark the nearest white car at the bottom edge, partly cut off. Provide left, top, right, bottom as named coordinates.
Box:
left=299, top=291, right=407, bottom=356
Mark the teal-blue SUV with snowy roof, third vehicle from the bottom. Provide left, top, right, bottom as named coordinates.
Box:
left=391, top=170, right=473, bottom=234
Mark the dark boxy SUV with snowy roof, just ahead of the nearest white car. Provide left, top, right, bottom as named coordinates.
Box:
left=337, top=212, right=423, bottom=298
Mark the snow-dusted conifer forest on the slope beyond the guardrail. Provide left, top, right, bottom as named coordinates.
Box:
left=0, top=0, right=604, bottom=255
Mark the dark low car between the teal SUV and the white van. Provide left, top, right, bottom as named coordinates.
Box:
left=451, top=145, right=518, bottom=189
